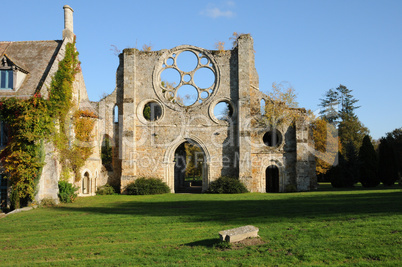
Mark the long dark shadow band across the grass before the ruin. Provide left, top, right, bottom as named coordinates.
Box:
left=58, top=191, right=402, bottom=224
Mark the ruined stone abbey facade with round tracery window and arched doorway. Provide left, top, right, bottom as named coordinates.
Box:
left=97, top=35, right=315, bottom=192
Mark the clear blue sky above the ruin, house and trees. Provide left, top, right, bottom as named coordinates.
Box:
left=0, top=0, right=402, bottom=138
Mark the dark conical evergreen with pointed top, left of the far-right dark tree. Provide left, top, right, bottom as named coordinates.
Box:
left=359, top=135, right=380, bottom=187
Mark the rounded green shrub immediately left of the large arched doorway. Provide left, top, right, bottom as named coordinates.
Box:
left=126, top=177, right=170, bottom=195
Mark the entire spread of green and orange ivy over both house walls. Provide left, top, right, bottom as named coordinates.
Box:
left=0, top=40, right=96, bottom=206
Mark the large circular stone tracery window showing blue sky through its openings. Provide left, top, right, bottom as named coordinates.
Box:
left=154, top=45, right=219, bottom=107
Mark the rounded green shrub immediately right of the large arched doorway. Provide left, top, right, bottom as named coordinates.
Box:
left=207, top=176, right=248, bottom=194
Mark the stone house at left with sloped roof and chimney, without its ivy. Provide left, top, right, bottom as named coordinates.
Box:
left=0, top=6, right=101, bottom=208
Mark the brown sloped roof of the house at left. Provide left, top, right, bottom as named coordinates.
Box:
left=0, top=40, right=63, bottom=97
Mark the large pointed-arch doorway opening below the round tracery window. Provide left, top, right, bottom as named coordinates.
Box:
left=174, top=141, right=206, bottom=193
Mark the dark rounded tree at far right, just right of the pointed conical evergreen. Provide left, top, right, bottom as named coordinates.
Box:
left=378, top=137, right=398, bottom=186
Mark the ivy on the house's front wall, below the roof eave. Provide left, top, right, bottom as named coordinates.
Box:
left=0, top=94, right=52, bottom=203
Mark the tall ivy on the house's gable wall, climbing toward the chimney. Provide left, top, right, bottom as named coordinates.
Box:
left=49, top=38, right=96, bottom=181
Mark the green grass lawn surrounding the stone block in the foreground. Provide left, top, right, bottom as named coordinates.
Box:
left=0, top=186, right=402, bottom=266
